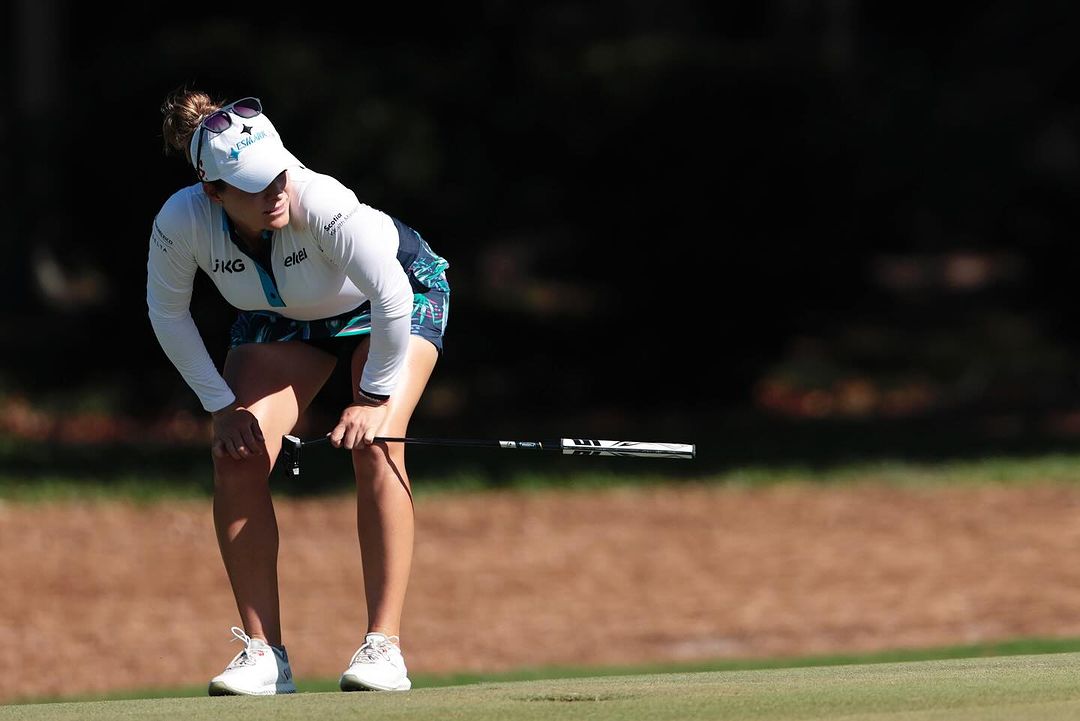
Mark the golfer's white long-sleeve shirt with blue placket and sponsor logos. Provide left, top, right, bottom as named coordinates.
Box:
left=146, top=167, right=413, bottom=411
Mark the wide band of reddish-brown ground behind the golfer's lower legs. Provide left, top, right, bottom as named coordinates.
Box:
left=6, top=485, right=1080, bottom=702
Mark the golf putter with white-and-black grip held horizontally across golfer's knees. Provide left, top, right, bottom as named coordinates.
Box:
left=281, top=435, right=697, bottom=476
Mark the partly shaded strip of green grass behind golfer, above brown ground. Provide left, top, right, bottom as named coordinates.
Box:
left=10, top=405, right=1080, bottom=502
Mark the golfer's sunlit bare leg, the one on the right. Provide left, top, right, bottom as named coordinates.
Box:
left=352, top=336, right=438, bottom=636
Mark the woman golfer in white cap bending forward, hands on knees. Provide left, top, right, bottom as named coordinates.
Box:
left=147, top=91, right=449, bottom=695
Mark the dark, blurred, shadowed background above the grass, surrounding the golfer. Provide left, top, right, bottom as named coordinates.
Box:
left=0, top=0, right=1080, bottom=473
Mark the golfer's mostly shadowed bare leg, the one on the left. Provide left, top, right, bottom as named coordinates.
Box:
left=214, top=341, right=335, bottom=645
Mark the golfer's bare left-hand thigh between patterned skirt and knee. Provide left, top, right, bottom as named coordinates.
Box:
left=222, top=341, right=336, bottom=446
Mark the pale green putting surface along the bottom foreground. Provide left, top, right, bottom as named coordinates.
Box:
left=0, top=653, right=1080, bottom=721
